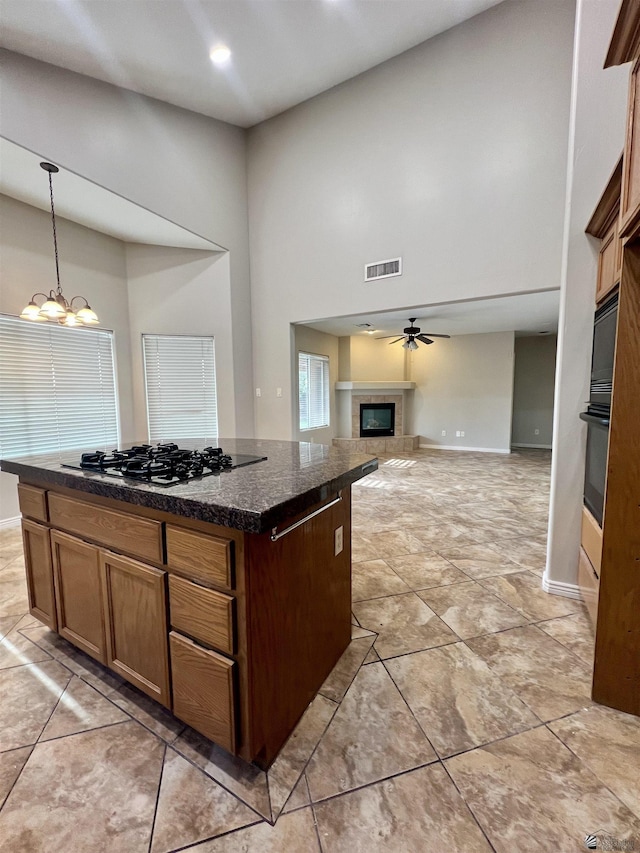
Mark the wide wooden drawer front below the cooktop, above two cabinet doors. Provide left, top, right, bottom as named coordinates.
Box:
left=49, top=492, right=162, bottom=563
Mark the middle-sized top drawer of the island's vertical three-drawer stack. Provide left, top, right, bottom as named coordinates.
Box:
left=167, top=524, right=234, bottom=589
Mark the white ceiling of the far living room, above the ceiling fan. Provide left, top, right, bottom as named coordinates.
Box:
left=301, top=290, right=560, bottom=338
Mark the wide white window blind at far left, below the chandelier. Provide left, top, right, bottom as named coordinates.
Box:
left=0, top=317, right=119, bottom=458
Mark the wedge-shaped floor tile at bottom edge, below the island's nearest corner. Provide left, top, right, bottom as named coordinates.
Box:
left=181, top=808, right=321, bottom=853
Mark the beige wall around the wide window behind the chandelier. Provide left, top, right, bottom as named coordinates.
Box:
left=0, top=195, right=133, bottom=521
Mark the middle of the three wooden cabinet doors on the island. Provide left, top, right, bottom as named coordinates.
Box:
left=51, top=530, right=107, bottom=663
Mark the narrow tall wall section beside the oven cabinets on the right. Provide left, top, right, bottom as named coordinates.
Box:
left=543, top=0, right=629, bottom=591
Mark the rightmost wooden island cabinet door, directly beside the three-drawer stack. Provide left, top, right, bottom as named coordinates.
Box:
left=100, top=550, right=171, bottom=708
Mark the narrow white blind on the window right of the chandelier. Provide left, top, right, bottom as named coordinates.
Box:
left=142, top=335, right=218, bottom=441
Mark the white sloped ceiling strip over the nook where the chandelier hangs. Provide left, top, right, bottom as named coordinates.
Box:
left=0, top=137, right=223, bottom=251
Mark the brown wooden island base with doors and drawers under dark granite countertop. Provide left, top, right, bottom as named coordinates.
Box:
left=11, top=483, right=351, bottom=767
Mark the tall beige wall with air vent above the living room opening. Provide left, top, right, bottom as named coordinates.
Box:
left=248, top=0, right=574, bottom=437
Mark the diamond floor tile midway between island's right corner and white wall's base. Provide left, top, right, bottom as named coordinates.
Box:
left=418, top=581, right=527, bottom=639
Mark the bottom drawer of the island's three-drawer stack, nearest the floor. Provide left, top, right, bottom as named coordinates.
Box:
left=169, top=631, right=236, bottom=752
